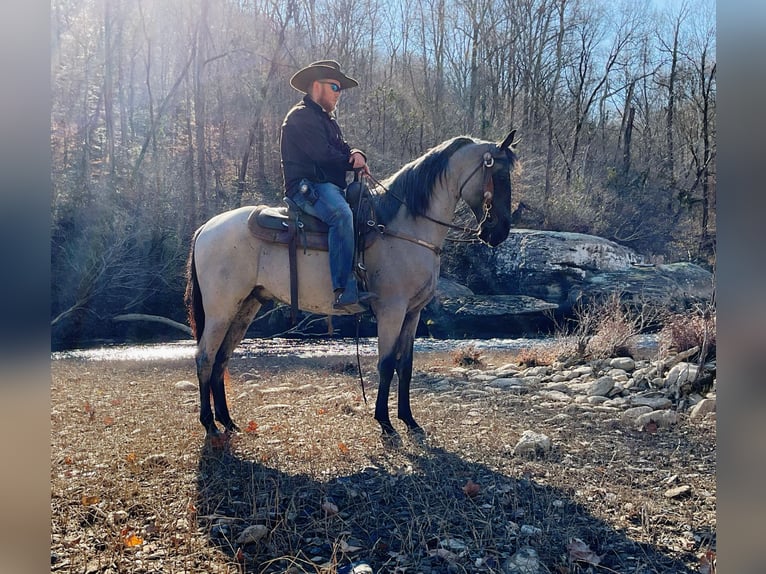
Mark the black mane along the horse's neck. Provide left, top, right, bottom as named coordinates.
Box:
left=375, top=136, right=475, bottom=225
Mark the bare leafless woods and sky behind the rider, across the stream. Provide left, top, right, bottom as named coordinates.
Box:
left=51, top=0, right=716, bottom=348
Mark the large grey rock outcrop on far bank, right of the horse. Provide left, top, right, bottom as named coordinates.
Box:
left=422, top=229, right=714, bottom=338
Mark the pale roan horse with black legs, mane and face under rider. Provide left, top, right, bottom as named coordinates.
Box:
left=186, top=130, right=516, bottom=439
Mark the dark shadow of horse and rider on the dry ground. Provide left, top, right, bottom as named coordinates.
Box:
left=196, top=440, right=696, bottom=574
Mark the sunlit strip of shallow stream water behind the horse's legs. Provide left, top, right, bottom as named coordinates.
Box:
left=51, top=337, right=553, bottom=361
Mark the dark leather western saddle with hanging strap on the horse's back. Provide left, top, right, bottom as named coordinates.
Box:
left=247, top=181, right=377, bottom=325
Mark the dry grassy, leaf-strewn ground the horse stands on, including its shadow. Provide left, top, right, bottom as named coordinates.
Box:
left=51, top=353, right=716, bottom=574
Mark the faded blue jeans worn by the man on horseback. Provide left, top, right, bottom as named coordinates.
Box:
left=292, top=182, right=356, bottom=291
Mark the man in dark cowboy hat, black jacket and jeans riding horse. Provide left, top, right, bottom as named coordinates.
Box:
left=281, top=60, right=375, bottom=313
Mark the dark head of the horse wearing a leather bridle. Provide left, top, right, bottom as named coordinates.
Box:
left=460, top=130, right=517, bottom=247
